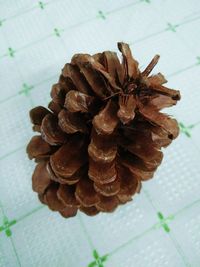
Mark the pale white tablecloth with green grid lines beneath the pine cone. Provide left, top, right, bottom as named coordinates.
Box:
left=0, top=0, right=200, bottom=267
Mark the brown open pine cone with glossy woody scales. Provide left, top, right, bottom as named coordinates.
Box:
left=27, top=43, right=180, bottom=217
